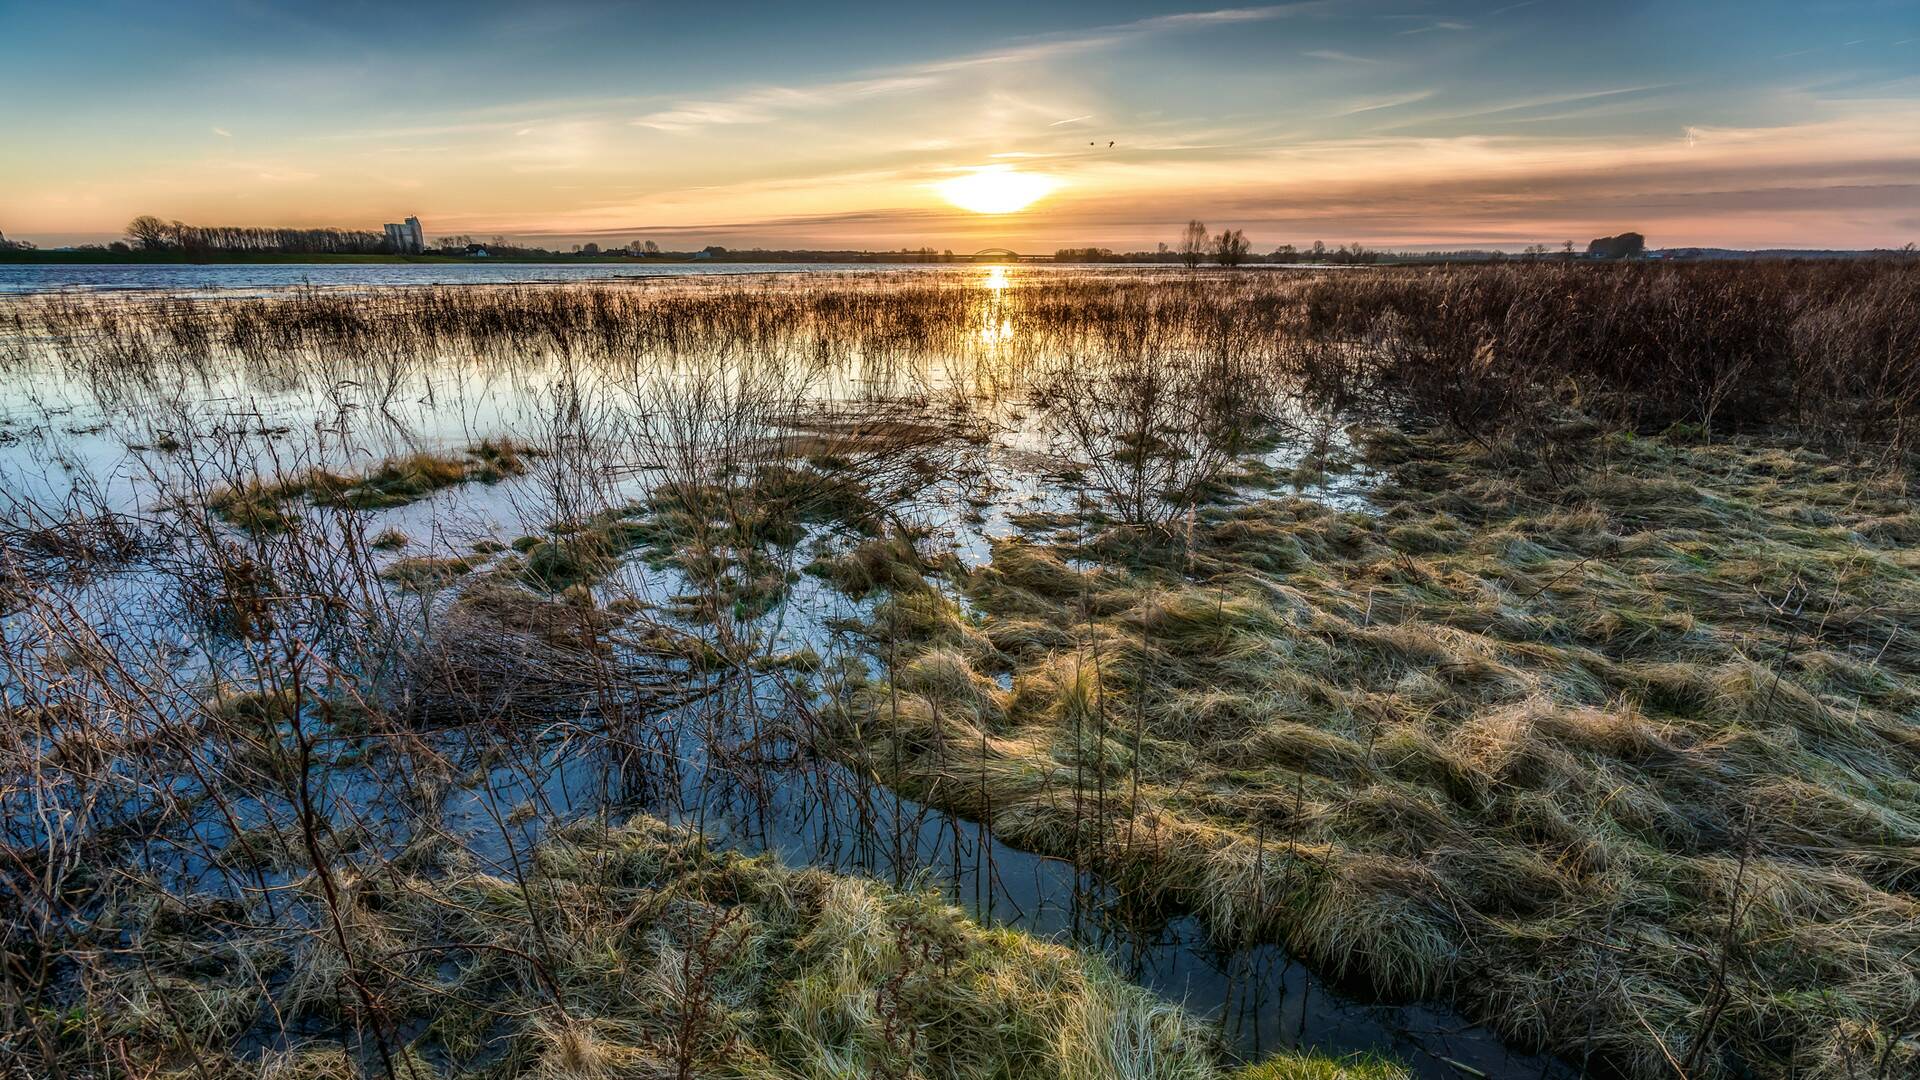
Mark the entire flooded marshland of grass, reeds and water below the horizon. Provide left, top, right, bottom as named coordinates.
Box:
left=0, top=259, right=1920, bottom=1080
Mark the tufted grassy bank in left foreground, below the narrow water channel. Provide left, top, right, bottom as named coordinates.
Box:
left=58, top=819, right=1405, bottom=1080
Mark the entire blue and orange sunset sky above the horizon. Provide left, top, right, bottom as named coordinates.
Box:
left=0, top=0, right=1920, bottom=252
